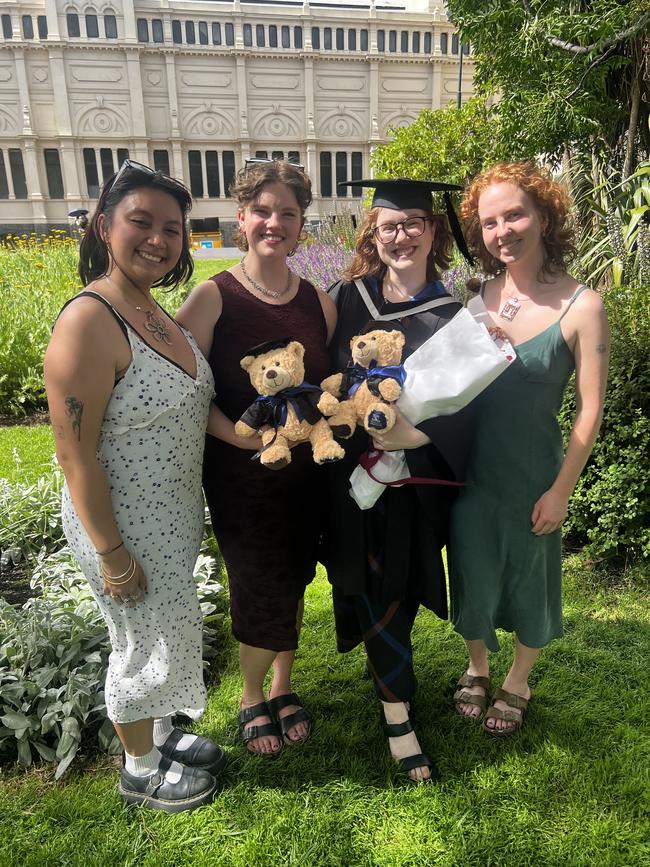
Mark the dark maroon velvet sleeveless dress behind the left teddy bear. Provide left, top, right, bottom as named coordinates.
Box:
left=203, top=272, right=329, bottom=651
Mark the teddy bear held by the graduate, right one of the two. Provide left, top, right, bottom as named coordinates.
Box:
left=321, top=322, right=405, bottom=439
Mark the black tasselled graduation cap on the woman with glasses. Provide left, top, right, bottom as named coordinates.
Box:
left=338, top=178, right=474, bottom=265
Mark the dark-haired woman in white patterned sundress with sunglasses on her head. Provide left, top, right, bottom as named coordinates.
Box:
left=45, top=160, right=225, bottom=812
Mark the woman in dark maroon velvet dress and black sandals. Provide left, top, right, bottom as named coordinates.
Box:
left=177, top=161, right=336, bottom=755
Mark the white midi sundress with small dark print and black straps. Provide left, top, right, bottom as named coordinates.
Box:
left=62, top=293, right=214, bottom=723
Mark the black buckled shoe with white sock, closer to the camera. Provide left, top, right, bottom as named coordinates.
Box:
left=118, top=757, right=217, bottom=813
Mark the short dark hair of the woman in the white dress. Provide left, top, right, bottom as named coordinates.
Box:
left=79, top=167, right=194, bottom=286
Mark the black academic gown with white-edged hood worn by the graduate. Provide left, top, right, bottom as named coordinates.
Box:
left=322, top=280, right=474, bottom=617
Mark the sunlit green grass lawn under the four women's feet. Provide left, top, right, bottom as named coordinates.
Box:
left=0, top=560, right=650, bottom=867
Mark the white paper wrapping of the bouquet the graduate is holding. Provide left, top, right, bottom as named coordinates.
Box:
left=350, top=304, right=515, bottom=509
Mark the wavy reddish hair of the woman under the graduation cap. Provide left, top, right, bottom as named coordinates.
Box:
left=343, top=208, right=452, bottom=281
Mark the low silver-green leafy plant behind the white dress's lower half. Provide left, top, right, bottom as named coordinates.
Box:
left=0, top=549, right=224, bottom=779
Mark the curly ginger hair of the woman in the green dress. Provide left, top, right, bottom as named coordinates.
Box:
left=460, top=162, right=575, bottom=275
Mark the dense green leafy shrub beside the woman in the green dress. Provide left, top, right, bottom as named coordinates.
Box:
left=560, top=286, right=650, bottom=560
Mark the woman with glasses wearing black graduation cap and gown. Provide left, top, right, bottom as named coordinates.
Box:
left=323, top=179, right=473, bottom=782
